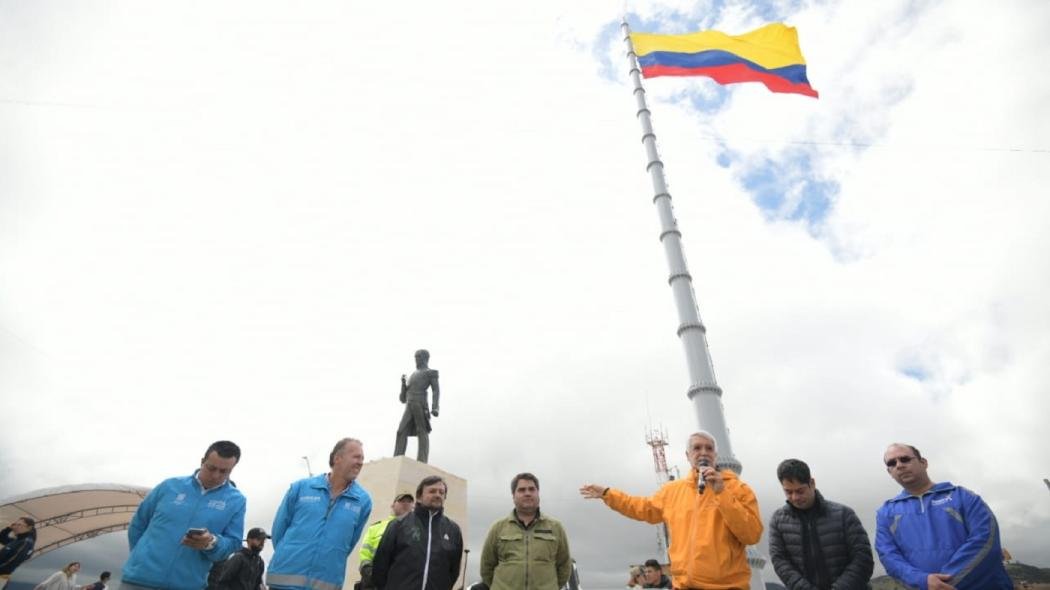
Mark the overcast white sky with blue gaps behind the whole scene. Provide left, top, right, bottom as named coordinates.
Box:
left=0, top=0, right=1050, bottom=588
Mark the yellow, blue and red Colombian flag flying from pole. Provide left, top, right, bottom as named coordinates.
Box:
left=631, top=23, right=818, bottom=99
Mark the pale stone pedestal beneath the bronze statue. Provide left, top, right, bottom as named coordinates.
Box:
left=342, top=456, right=468, bottom=590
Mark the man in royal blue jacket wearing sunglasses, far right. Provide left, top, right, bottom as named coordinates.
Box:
left=875, top=443, right=1013, bottom=590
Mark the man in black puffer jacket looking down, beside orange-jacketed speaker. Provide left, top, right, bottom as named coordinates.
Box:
left=770, top=459, right=875, bottom=590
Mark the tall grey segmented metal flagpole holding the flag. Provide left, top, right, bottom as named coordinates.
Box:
left=621, top=18, right=742, bottom=473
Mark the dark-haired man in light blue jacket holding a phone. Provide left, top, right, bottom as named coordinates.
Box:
left=121, top=441, right=246, bottom=590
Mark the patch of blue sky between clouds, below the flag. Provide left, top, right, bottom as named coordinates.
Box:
left=743, top=150, right=840, bottom=227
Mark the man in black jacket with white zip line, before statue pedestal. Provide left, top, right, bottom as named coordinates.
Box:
left=372, top=476, right=463, bottom=590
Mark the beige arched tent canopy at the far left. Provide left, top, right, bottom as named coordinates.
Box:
left=0, top=484, right=150, bottom=559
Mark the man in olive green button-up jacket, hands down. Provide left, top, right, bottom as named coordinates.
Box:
left=481, top=473, right=572, bottom=590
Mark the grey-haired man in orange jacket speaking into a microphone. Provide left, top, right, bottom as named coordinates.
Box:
left=580, top=431, right=762, bottom=590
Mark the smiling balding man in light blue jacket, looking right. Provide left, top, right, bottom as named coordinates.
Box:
left=267, top=439, right=372, bottom=590
